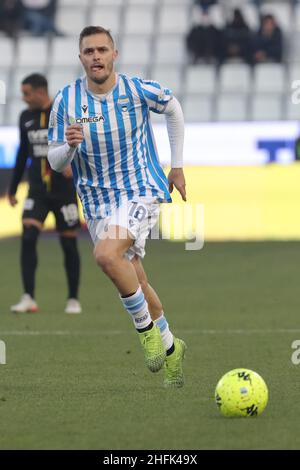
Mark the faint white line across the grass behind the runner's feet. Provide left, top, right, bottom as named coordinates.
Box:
left=0, top=328, right=300, bottom=337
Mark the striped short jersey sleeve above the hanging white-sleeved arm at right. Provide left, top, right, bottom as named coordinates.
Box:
left=135, top=79, right=173, bottom=114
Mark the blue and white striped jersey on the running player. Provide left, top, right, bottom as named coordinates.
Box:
left=48, top=74, right=172, bottom=219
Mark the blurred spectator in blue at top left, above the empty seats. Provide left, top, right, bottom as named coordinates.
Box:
left=21, top=0, right=61, bottom=36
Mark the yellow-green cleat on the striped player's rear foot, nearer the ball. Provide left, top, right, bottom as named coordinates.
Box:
left=164, top=338, right=187, bottom=388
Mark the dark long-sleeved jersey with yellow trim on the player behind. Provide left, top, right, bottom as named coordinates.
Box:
left=9, top=106, right=75, bottom=197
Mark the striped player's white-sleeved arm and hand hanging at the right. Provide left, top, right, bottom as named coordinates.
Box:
left=164, top=97, right=186, bottom=201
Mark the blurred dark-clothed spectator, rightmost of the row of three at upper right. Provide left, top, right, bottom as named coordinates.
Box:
left=253, top=15, right=283, bottom=64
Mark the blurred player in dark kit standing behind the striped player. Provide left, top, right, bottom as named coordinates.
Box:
left=8, top=74, right=81, bottom=314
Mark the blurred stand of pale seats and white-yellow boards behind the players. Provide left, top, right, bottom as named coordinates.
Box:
left=0, top=0, right=300, bottom=240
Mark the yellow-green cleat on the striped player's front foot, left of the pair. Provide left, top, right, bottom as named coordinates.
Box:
left=138, top=325, right=166, bottom=372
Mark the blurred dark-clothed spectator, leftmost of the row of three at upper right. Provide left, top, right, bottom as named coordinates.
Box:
left=186, top=14, right=220, bottom=64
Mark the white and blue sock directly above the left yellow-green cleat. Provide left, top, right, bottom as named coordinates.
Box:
left=120, top=286, right=152, bottom=330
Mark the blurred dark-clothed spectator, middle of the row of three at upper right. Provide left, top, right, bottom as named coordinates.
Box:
left=222, top=8, right=251, bottom=62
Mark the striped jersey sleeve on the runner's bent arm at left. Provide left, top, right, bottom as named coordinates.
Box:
left=48, top=92, right=67, bottom=144
